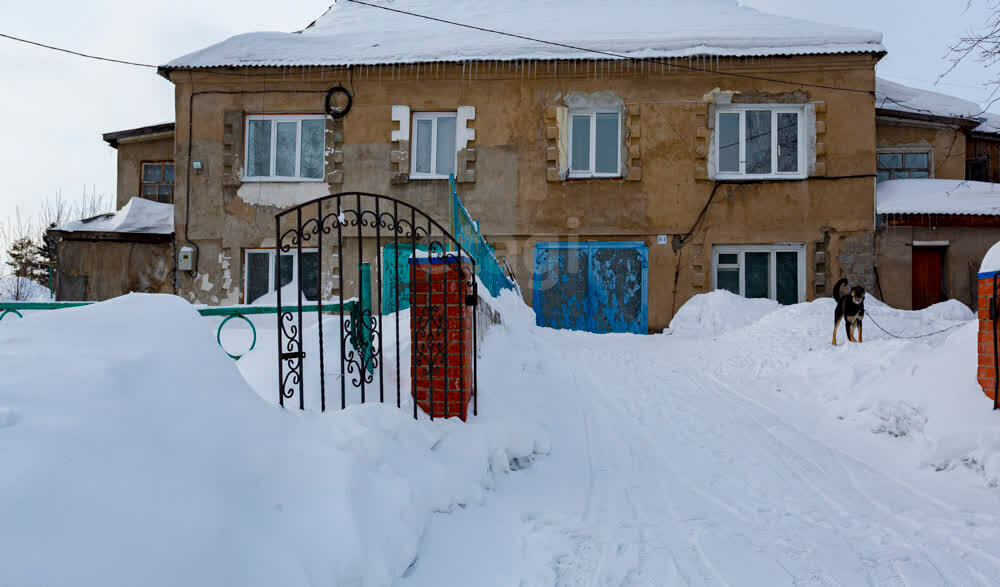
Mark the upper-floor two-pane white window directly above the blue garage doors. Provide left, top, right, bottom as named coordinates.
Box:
left=569, top=109, right=622, bottom=178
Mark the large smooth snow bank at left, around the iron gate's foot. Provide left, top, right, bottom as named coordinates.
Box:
left=0, top=294, right=547, bottom=586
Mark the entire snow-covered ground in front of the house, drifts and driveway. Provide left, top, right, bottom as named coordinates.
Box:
left=0, top=292, right=1000, bottom=586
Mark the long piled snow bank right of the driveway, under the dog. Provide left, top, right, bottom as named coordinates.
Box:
left=671, top=292, right=1000, bottom=485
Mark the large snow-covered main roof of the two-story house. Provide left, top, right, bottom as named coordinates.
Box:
left=163, top=0, right=885, bottom=69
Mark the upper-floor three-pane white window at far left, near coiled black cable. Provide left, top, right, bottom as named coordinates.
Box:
left=243, top=114, right=326, bottom=181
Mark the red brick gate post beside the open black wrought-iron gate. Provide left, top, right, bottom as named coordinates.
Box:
left=410, top=255, right=475, bottom=421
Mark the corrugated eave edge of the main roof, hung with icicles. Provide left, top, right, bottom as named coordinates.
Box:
left=157, top=44, right=888, bottom=77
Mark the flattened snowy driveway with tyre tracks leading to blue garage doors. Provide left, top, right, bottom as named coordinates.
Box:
left=394, top=322, right=1000, bottom=586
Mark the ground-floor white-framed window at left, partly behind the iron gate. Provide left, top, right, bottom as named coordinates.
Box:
left=243, top=249, right=319, bottom=304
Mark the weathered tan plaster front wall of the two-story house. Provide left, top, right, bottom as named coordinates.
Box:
left=171, top=55, right=877, bottom=329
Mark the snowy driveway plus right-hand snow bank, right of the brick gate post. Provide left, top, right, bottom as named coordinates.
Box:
left=400, top=293, right=1000, bottom=586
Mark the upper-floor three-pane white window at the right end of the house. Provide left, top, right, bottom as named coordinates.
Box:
left=715, top=104, right=808, bottom=179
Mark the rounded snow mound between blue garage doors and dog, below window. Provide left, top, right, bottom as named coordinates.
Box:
left=669, top=289, right=778, bottom=337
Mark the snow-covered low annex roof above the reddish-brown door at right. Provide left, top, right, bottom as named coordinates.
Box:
left=876, top=179, right=1000, bottom=216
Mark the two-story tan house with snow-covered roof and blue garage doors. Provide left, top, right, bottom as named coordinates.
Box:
left=148, top=0, right=884, bottom=329
